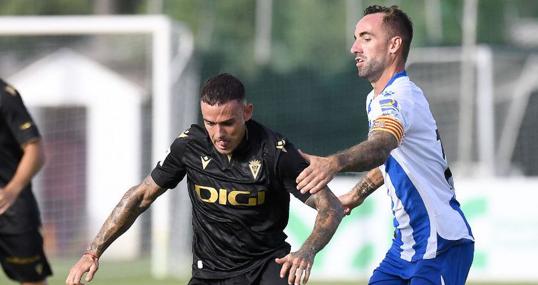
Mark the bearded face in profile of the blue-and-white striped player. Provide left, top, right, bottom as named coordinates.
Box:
left=351, top=13, right=389, bottom=82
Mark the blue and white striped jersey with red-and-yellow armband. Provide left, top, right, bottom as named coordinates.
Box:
left=366, top=71, right=474, bottom=261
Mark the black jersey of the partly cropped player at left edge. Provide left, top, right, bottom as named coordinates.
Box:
left=0, top=79, right=40, bottom=233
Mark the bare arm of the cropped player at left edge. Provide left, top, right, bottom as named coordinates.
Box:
left=0, top=138, right=45, bottom=215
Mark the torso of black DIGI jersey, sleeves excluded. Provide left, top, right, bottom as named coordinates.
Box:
left=183, top=122, right=289, bottom=275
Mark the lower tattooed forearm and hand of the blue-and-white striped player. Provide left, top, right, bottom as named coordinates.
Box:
left=338, top=167, right=384, bottom=215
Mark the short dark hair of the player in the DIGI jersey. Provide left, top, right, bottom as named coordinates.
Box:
left=200, top=73, right=245, bottom=106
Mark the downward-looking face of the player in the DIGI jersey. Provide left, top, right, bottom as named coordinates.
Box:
left=200, top=100, right=253, bottom=154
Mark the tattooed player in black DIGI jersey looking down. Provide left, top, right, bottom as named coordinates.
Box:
left=66, top=74, right=343, bottom=285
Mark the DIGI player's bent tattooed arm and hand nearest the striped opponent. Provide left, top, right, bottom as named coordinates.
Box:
left=275, top=188, right=344, bottom=284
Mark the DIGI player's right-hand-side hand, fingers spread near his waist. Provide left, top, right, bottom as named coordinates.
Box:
left=275, top=246, right=316, bottom=285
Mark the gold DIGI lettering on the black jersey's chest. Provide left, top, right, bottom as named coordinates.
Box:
left=194, top=184, right=265, bottom=206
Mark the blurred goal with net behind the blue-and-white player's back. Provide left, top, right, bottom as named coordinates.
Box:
left=407, top=46, right=538, bottom=177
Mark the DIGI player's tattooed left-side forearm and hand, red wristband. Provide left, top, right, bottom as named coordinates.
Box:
left=65, top=176, right=165, bottom=285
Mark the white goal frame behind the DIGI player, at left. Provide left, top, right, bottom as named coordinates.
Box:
left=0, top=15, right=199, bottom=277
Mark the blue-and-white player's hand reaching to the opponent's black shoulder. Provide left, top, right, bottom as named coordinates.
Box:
left=295, top=150, right=338, bottom=194
